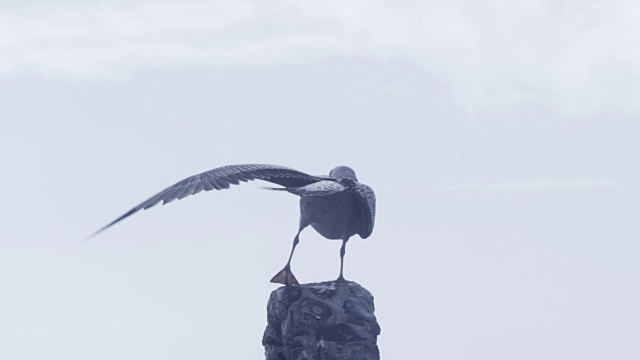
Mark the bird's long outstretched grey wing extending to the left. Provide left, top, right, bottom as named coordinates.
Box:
left=90, top=164, right=323, bottom=237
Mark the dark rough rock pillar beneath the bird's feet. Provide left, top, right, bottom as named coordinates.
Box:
left=262, top=281, right=380, bottom=360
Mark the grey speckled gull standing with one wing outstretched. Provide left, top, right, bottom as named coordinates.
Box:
left=88, top=164, right=376, bottom=286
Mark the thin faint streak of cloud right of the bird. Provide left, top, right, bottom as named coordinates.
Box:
left=448, top=178, right=617, bottom=191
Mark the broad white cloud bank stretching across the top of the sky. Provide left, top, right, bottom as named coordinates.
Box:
left=0, top=0, right=640, bottom=122
